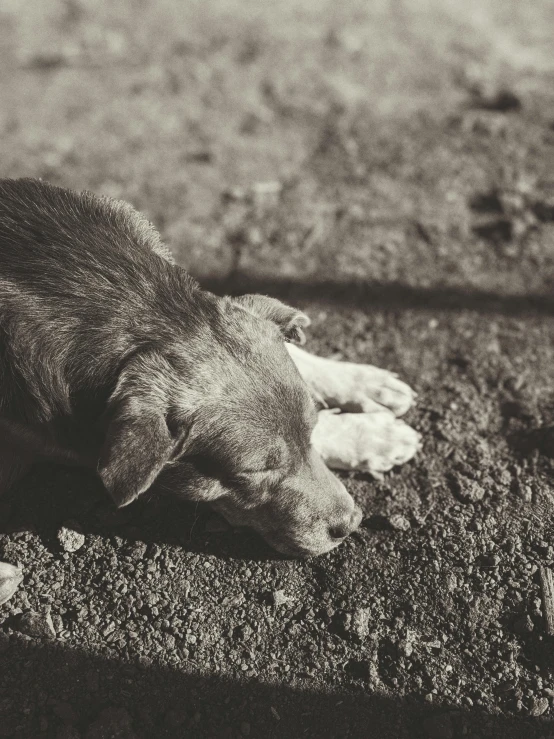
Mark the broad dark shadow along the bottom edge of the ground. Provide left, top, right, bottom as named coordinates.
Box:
left=0, top=632, right=545, bottom=739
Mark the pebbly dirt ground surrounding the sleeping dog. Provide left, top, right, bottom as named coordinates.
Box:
left=0, top=0, right=554, bottom=739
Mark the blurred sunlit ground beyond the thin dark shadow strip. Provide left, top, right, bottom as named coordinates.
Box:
left=0, top=0, right=554, bottom=295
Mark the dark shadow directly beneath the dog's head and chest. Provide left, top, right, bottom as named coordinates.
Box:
left=0, top=465, right=276, bottom=561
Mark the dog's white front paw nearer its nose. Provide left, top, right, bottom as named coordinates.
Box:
left=312, top=409, right=421, bottom=479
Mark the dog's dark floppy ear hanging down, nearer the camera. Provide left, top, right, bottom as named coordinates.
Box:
left=98, top=361, right=181, bottom=507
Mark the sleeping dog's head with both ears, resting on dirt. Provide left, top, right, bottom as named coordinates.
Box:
left=99, top=293, right=361, bottom=556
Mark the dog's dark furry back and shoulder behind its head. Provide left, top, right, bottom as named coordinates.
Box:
left=0, top=180, right=213, bottom=430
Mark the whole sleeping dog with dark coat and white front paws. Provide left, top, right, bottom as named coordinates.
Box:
left=0, top=179, right=419, bottom=600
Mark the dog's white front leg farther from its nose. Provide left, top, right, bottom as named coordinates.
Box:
left=287, top=344, right=416, bottom=416
